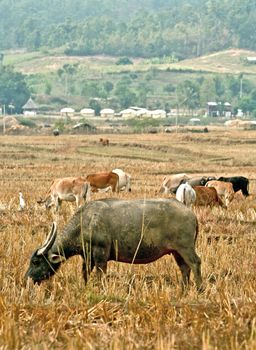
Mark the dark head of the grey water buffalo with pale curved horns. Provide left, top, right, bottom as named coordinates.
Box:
left=25, top=223, right=65, bottom=283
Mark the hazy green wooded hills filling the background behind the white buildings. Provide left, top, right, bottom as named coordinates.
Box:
left=0, top=0, right=256, bottom=115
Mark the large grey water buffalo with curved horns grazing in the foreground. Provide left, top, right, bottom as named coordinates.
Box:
left=25, top=198, right=202, bottom=291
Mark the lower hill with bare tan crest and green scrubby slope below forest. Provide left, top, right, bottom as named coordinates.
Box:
left=3, top=49, right=256, bottom=113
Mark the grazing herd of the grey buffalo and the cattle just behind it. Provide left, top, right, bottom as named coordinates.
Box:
left=26, top=169, right=249, bottom=291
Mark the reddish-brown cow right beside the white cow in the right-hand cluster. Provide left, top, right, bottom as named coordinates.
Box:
left=193, top=186, right=226, bottom=207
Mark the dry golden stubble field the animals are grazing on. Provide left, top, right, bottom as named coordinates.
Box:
left=0, top=128, right=256, bottom=350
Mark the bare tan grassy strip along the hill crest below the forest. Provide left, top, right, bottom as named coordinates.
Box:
left=4, top=49, right=256, bottom=74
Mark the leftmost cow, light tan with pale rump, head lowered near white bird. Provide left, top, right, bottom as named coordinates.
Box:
left=37, top=177, right=90, bottom=212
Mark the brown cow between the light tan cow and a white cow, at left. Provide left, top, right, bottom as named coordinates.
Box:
left=86, top=171, right=119, bottom=192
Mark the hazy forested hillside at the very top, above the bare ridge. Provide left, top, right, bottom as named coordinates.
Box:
left=0, top=0, right=256, bottom=60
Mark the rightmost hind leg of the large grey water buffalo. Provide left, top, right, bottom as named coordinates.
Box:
left=176, top=248, right=203, bottom=292
